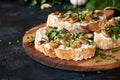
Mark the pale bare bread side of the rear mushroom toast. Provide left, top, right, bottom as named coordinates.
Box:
left=47, top=13, right=87, bottom=32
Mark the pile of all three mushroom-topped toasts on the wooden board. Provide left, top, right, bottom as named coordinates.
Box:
left=35, top=9, right=120, bottom=61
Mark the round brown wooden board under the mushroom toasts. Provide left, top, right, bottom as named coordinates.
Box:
left=23, top=24, right=120, bottom=71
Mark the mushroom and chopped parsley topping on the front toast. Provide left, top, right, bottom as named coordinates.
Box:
left=45, top=27, right=93, bottom=48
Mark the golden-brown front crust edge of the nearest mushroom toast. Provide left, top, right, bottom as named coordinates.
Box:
left=35, top=44, right=95, bottom=61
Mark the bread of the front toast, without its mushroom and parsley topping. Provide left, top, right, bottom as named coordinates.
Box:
left=35, top=27, right=95, bottom=61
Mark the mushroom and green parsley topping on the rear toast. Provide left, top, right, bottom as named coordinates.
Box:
left=58, top=7, right=100, bottom=23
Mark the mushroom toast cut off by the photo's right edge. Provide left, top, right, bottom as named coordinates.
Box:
left=94, top=17, right=120, bottom=50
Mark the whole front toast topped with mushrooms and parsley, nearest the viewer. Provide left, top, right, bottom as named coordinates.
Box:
left=35, top=27, right=96, bottom=61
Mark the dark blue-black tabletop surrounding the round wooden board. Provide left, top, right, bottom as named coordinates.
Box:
left=0, top=1, right=120, bottom=80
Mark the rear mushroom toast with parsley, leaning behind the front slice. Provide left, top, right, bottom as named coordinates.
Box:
left=47, top=10, right=114, bottom=32
